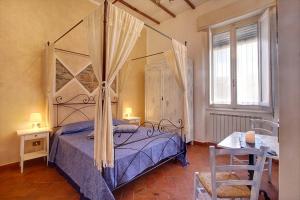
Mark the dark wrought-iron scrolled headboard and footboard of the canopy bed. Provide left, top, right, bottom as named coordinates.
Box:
left=53, top=94, right=186, bottom=191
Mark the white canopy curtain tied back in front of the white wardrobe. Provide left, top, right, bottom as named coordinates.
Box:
left=164, top=39, right=192, bottom=139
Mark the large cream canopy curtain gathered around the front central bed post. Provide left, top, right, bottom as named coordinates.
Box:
left=85, top=4, right=144, bottom=170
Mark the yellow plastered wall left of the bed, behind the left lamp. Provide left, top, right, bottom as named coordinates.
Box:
left=0, top=0, right=95, bottom=165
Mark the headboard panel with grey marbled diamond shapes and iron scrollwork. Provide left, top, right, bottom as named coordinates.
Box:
left=53, top=50, right=118, bottom=127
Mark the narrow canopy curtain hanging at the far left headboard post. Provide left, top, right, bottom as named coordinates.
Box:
left=45, top=44, right=55, bottom=128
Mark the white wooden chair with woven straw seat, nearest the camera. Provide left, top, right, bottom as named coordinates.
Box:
left=194, top=146, right=268, bottom=200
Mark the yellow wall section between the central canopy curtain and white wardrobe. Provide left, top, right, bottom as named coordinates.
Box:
left=118, top=30, right=147, bottom=120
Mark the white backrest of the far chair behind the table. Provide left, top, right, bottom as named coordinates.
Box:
left=250, top=119, right=279, bottom=136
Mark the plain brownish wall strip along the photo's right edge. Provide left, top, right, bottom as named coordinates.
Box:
left=278, top=0, right=300, bottom=200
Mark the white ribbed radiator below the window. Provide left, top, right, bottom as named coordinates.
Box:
left=208, top=113, right=261, bottom=143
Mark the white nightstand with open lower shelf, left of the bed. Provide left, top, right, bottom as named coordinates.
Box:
left=17, top=128, right=51, bottom=173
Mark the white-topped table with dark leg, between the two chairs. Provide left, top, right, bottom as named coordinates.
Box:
left=218, top=132, right=279, bottom=199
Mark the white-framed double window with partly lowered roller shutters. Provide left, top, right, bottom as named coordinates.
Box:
left=209, top=13, right=271, bottom=108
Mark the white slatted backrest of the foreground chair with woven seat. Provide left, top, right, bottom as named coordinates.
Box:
left=209, top=146, right=269, bottom=200
